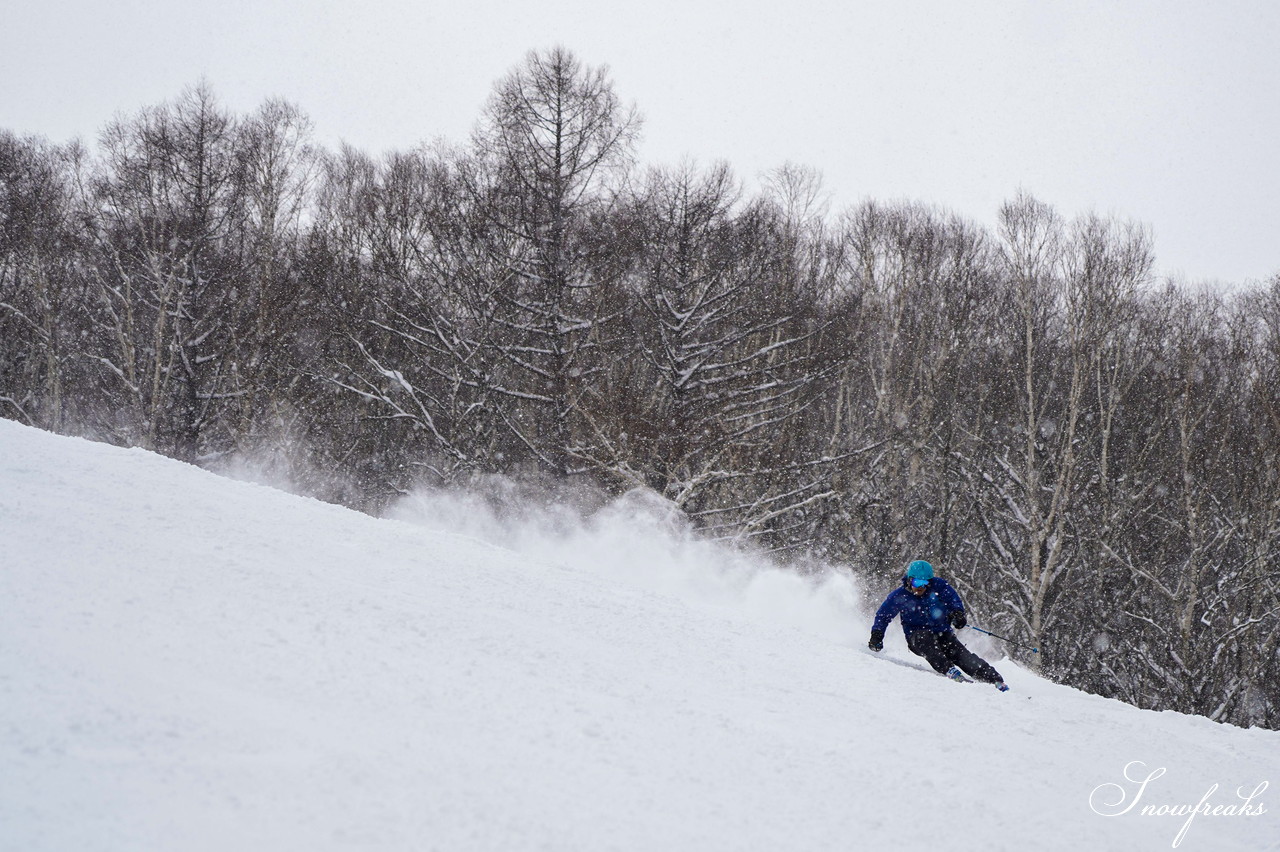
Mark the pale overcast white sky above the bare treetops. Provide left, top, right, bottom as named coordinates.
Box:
left=0, top=0, right=1280, bottom=284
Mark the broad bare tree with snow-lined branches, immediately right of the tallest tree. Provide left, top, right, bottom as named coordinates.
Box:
left=602, top=165, right=832, bottom=544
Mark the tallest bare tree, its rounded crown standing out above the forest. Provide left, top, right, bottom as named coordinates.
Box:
left=475, top=47, right=640, bottom=475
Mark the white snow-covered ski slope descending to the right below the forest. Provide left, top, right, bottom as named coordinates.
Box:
left=0, top=421, right=1280, bottom=852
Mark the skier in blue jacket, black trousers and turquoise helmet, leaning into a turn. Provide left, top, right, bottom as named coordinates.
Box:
left=867, top=559, right=1009, bottom=692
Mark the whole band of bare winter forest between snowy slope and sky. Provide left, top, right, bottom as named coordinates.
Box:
left=0, top=49, right=1280, bottom=728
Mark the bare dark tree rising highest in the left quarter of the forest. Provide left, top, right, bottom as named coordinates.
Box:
left=85, top=84, right=242, bottom=459
